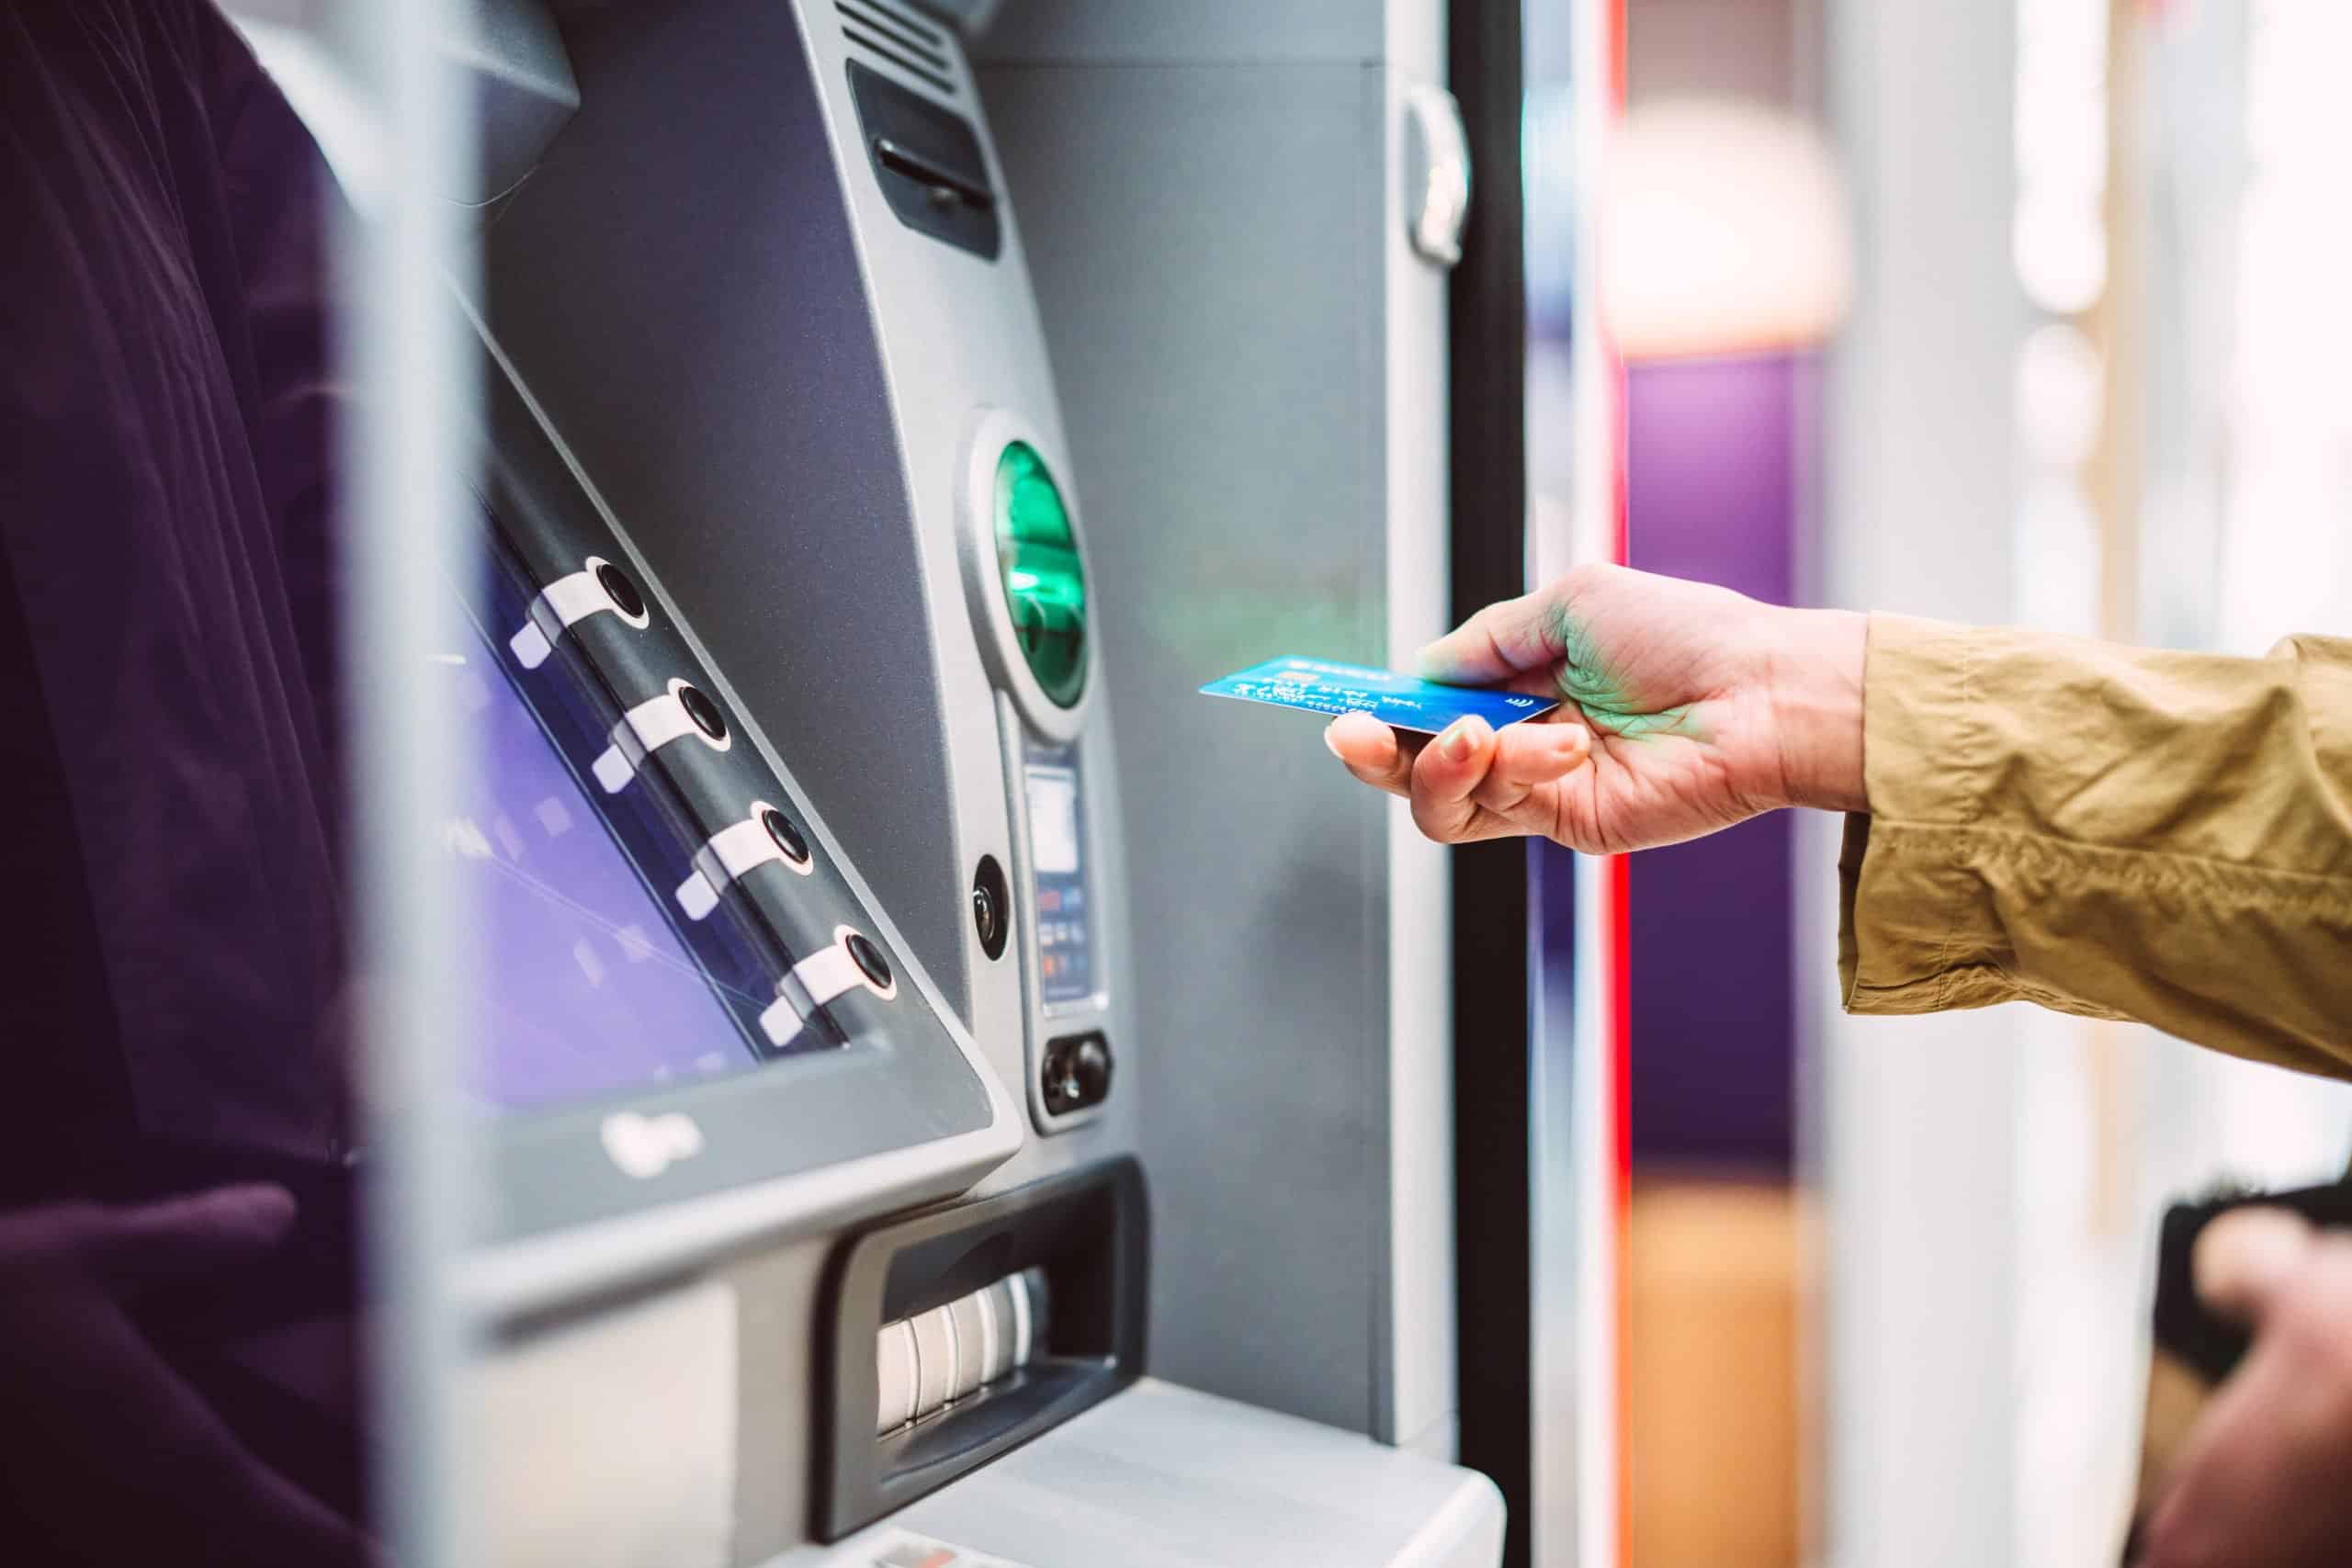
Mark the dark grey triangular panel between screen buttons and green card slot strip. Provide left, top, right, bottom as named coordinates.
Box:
left=484, top=5, right=971, bottom=1021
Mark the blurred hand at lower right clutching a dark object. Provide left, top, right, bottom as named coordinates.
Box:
left=2135, top=1208, right=2352, bottom=1568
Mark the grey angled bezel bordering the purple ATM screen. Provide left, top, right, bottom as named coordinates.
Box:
left=448, top=339, right=1021, bottom=1298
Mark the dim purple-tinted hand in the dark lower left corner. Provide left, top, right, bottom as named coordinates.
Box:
left=0, top=1185, right=371, bottom=1568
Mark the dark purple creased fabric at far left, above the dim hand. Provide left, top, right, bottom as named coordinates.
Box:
left=0, top=0, right=348, bottom=1197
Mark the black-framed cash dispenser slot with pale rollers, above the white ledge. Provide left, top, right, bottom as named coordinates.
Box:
left=814, top=1156, right=1150, bottom=1542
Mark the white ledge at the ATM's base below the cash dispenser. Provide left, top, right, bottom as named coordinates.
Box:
left=808, top=1378, right=1503, bottom=1568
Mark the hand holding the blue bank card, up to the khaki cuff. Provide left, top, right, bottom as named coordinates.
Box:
left=1324, top=567, right=1865, bottom=853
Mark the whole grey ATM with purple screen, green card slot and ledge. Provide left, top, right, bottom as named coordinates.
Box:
left=253, top=0, right=1503, bottom=1568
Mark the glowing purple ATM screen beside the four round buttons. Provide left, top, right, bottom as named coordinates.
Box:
left=442, top=573, right=795, bottom=1112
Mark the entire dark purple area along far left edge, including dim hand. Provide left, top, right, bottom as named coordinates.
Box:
left=0, top=12, right=367, bottom=1563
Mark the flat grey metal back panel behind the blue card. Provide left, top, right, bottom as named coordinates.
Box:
left=983, top=66, right=1392, bottom=1432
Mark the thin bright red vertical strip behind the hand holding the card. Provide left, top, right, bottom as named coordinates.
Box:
left=1588, top=0, right=1633, bottom=1568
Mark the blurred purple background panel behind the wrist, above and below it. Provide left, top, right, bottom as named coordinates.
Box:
left=1625, top=355, right=1814, bottom=1176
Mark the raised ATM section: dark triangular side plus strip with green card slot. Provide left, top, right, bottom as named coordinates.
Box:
left=484, top=0, right=1134, bottom=1168
